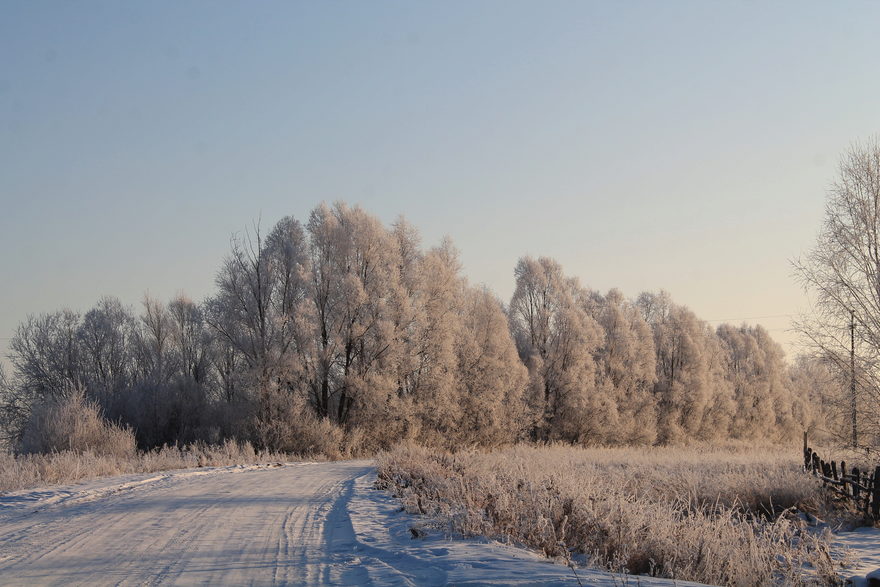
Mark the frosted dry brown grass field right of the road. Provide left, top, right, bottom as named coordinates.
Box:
left=379, top=446, right=836, bottom=585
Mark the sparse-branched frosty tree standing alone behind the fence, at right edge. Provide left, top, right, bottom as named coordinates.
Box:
left=794, top=138, right=880, bottom=445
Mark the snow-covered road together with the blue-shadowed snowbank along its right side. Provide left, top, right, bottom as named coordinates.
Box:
left=0, top=461, right=700, bottom=586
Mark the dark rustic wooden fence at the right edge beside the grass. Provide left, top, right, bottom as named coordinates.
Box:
left=804, top=435, right=880, bottom=520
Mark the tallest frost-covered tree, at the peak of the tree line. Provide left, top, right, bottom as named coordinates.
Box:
left=307, top=203, right=402, bottom=423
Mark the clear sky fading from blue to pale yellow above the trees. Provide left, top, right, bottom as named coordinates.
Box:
left=0, top=0, right=880, bottom=366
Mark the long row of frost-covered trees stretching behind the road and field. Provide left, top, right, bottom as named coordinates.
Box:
left=0, top=203, right=839, bottom=452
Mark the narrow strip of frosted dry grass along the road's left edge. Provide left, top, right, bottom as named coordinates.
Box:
left=0, top=440, right=291, bottom=491
